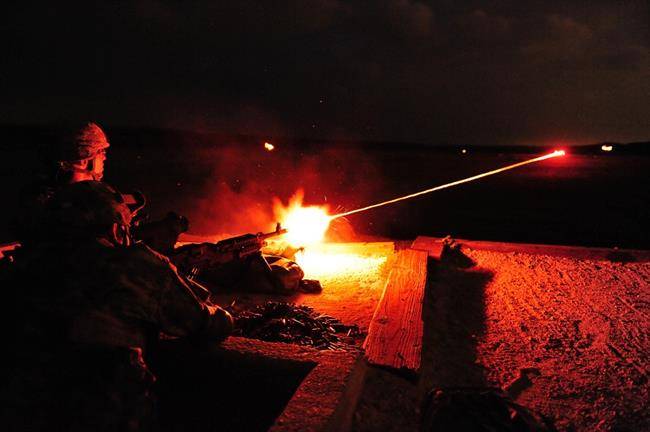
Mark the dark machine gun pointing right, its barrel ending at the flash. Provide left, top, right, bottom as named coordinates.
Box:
left=169, top=223, right=287, bottom=276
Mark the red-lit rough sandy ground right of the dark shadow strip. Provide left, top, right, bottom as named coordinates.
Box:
left=468, top=251, right=650, bottom=431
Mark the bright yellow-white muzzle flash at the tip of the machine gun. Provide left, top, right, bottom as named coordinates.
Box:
left=273, top=190, right=332, bottom=247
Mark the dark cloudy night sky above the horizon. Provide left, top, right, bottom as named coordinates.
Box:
left=0, top=0, right=650, bottom=144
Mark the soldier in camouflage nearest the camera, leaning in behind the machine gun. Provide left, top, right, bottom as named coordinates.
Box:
left=0, top=181, right=232, bottom=431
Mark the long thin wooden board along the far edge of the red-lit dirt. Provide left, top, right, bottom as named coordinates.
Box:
left=413, top=236, right=650, bottom=262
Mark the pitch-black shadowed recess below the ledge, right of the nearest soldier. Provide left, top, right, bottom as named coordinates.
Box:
left=152, top=341, right=315, bottom=432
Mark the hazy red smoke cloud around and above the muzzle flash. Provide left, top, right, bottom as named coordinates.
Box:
left=184, top=139, right=382, bottom=240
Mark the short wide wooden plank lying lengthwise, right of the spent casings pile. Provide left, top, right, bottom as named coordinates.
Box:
left=363, top=249, right=427, bottom=373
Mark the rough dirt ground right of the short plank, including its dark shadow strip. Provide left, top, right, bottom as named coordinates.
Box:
left=354, top=250, right=650, bottom=431
